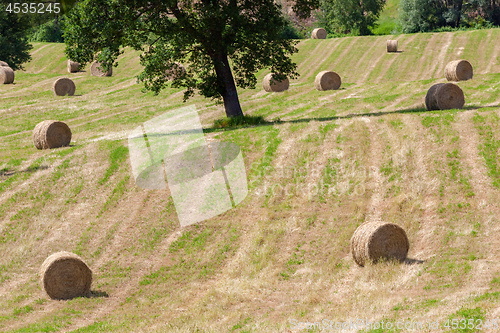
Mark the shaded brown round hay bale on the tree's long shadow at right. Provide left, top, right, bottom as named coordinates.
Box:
left=425, top=83, right=465, bottom=111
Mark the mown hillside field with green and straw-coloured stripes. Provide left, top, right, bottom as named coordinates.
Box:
left=0, top=29, right=500, bottom=332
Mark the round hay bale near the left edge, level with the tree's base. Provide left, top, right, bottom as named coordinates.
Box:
left=32, top=120, right=71, bottom=149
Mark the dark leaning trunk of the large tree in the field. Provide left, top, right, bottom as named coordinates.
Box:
left=215, top=54, right=243, bottom=118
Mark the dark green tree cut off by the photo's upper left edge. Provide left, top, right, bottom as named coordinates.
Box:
left=0, top=3, right=32, bottom=70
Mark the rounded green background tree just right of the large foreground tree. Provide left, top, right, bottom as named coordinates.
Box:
left=318, top=0, right=385, bottom=35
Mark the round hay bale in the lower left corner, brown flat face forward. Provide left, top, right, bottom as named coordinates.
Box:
left=40, top=251, right=92, bottom=299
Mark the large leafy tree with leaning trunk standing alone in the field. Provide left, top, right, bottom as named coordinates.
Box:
left=64, top=0, right=317, bottom=117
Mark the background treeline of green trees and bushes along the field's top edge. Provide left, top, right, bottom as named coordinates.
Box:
left=0, top=0, right=500, bottom=42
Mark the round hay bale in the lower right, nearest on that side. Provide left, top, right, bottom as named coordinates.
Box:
left=351, top=222, right=410, bottom=266
